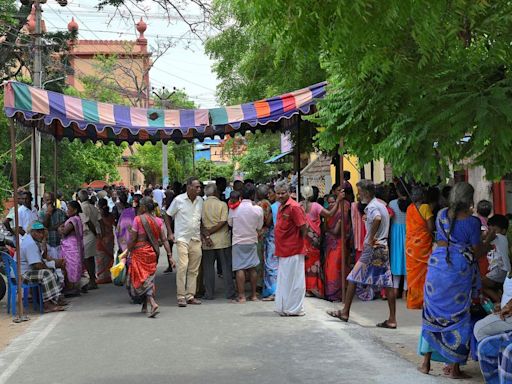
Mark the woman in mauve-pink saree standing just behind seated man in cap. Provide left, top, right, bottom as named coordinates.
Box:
left=59, top=201, right=84, bottom=293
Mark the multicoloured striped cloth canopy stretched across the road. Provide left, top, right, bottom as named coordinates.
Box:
left=4, top=82, right=326, bottom=144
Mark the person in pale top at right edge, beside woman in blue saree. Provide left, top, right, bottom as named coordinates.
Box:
left=482, top=215, right=511, bottom=303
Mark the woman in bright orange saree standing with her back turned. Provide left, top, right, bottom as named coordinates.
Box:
left=405, top=187, right=434, bottom=309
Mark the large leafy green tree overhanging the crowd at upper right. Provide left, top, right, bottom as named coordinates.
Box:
left=230, top=0, right=512, bottom=181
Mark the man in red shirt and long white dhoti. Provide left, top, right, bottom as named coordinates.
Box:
left=274, top=182, right=307, bottom=316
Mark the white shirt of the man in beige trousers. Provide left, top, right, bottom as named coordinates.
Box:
left=167, top=192, right=204, bottom=243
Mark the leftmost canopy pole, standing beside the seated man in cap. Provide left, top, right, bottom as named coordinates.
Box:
left=9, top=119, right=28, bottom=323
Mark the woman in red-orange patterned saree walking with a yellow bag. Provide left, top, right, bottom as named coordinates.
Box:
left=126, top=197, right=174, bottom=317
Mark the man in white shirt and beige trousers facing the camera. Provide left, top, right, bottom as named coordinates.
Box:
left=167, top=177, right=204, bottom=307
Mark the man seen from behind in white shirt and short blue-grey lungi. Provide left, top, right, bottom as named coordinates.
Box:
left=226, top=185, right=263, bottom=303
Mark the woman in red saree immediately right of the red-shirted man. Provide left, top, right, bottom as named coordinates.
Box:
left=301, top=186, right=338, bottom=298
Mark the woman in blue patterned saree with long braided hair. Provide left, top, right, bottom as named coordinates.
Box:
left=419, top=183, right=492, bottom=379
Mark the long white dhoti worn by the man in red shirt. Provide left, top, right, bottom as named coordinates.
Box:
left=275, top=255, right=306, bottom=316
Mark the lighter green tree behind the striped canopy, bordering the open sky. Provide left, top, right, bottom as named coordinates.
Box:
left=205, top=0, right=326, bottom=158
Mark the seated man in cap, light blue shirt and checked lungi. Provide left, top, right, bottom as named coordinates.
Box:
left=20, top=221, right=65, bottom=312
